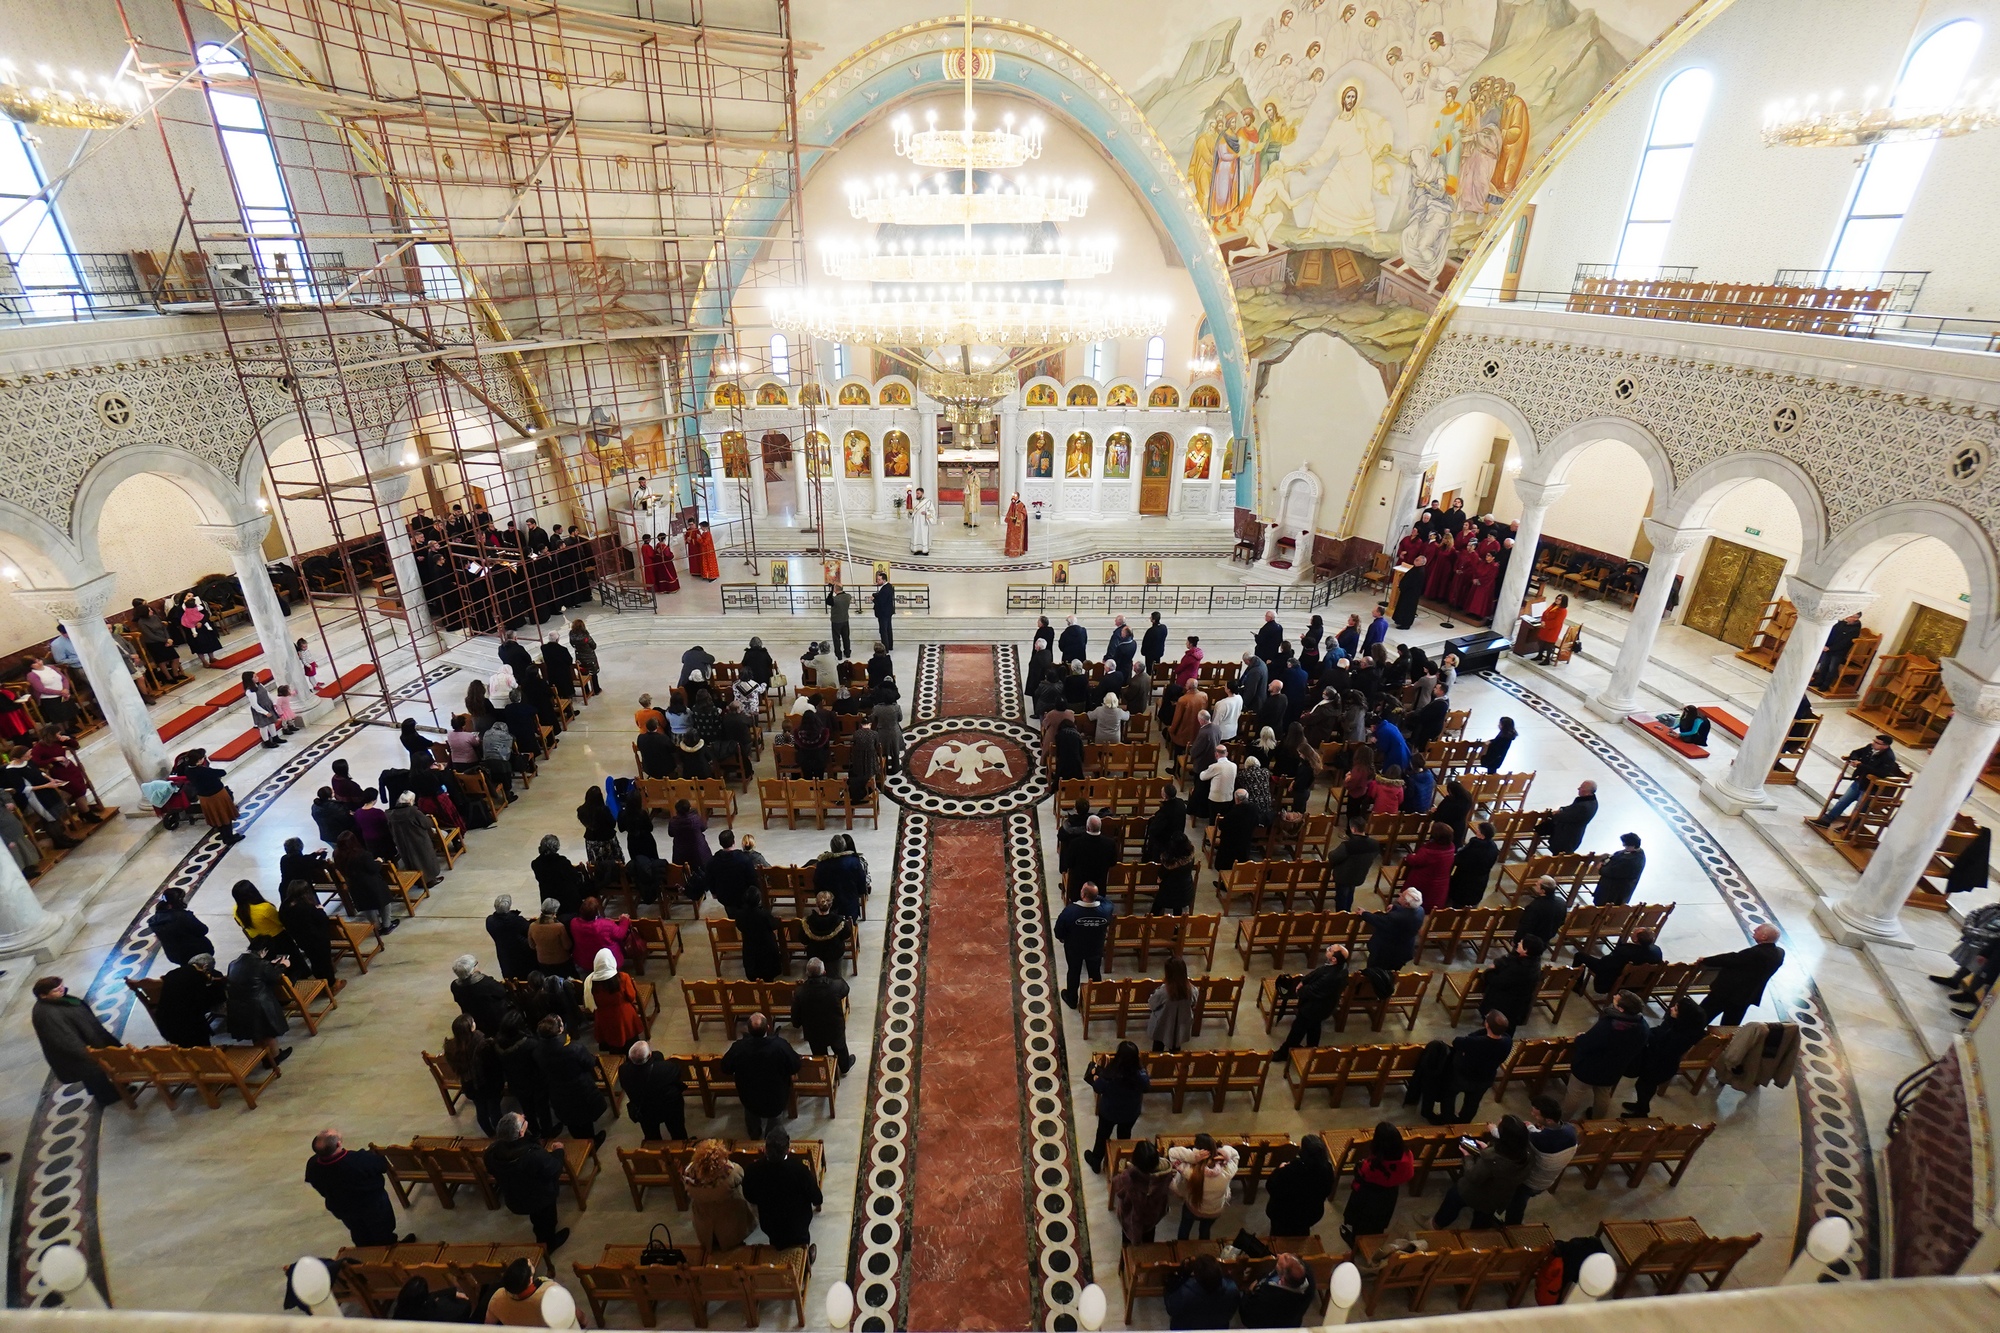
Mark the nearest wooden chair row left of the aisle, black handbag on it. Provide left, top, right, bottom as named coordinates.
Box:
left=570, top=1245, right=812, bottom=1329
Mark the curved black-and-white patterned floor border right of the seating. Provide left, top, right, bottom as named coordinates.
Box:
left=1480, top=671, right=1880, bottom=1279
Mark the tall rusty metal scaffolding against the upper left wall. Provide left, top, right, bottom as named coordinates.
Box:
left=120, top=0, right=824, bottom=719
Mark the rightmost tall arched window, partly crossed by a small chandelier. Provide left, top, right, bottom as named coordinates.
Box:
left=1826, top=18, right=1980, bottom=282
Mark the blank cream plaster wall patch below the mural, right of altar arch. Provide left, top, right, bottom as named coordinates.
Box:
left=1256, top=332, right=1388, bottom=532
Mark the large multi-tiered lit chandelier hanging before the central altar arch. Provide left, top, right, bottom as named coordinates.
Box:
left=770, top=4, right=1166, bottom=428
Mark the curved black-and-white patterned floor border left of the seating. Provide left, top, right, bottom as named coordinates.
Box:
left=8, top=667, right=458, bottom=1307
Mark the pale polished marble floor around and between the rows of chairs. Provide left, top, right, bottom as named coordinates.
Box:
left=0, top=588, right=1948, bottom=1327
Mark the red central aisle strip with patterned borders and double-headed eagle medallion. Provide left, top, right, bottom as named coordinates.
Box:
left=852, top=644, right=1090, bottom=1333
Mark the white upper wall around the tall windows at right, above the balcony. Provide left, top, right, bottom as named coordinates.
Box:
left=1522, top=0, right=2000, bottom=314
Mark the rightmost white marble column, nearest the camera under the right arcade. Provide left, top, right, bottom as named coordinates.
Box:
left=1820, top=656, right=2000, bottom=947
